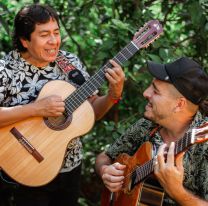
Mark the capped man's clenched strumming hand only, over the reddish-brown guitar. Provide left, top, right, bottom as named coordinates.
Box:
left=102, top=162, right=126, bottom=192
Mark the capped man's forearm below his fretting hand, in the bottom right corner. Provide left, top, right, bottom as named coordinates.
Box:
left=171, top=187, right=208, bottom=206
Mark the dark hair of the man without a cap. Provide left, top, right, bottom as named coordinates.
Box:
left=13, top=4, right=59, bottom=52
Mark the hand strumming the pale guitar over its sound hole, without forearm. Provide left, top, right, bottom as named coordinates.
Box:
left=33, top=95, right=65, bottom=117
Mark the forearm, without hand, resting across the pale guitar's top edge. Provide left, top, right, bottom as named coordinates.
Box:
left=0, top=104, right=34, bottom=127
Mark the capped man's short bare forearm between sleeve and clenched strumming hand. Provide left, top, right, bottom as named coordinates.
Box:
left=95, top=152, right=112, bottom=177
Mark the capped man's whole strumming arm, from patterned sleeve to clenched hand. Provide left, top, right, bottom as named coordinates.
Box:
left=95, top=119, right=150, bottom=192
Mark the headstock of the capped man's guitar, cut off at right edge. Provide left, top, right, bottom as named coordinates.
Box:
left=192, top=122, right=208, bottom=143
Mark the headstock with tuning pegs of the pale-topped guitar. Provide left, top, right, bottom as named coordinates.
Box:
left=133, top=20, right=163, bottom=48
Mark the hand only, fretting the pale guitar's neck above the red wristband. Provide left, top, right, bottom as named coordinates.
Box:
left=105, top=60, right=125, bottom=99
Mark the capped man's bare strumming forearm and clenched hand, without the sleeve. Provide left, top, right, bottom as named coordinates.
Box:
left=95, top=152, right=126, bottom=192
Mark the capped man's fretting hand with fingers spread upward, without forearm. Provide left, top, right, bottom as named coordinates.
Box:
left=154, top=142, right=184, bottom=199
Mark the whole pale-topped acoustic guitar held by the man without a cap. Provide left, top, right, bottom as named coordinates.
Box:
left=0, top=20, right=162, bottom=187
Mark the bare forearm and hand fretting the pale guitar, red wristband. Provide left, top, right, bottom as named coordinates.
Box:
left=89, top=60, right=125, bottom=120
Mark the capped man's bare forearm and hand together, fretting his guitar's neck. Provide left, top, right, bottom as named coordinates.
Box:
left=154, top=142, right=208, bottom=206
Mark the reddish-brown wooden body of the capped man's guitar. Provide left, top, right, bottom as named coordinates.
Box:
left=101, top=142, right=163, bottom=206
